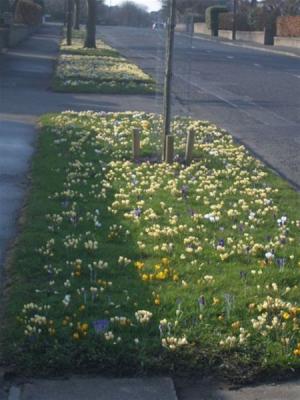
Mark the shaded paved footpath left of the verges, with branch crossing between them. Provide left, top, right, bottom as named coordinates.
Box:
left=0, top=24, right=161, bottom=265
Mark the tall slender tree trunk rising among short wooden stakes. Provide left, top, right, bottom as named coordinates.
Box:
left=162, top=0, right=176, bottom=161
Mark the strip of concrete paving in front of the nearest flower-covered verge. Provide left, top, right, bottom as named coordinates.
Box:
left=5, top=377, right=300, bottom=400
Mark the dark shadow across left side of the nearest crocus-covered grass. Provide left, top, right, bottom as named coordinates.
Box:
left=2, top=116, right=160, bottom=375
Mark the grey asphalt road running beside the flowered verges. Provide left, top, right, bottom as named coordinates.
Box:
left=98, top=27, right=300, bottom=188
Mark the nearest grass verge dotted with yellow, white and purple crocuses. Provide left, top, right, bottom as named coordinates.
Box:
left=2, top=112, right=300, bottom=381
